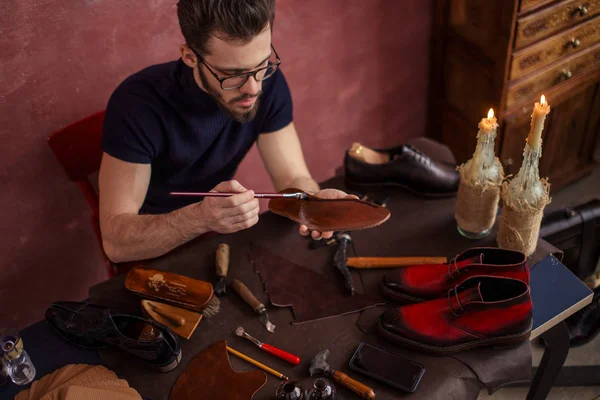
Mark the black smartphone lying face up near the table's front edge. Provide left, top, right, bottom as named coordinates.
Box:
left=350, top=342, right=425, bottom=393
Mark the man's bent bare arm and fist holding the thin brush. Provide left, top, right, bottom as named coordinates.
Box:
left=99, top=153, right=259, bottom=262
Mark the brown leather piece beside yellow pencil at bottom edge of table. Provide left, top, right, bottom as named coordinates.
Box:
left=169, top=340, right=267, bottom=400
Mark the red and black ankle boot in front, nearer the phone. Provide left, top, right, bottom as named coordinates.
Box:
left=379, top=276, right=532, bottom=355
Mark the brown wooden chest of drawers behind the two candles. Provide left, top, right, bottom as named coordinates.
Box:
left=428, top=0, right=600, bottom=188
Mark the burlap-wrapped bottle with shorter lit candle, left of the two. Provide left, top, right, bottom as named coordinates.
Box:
left=455, top=109, right=504, bottom=239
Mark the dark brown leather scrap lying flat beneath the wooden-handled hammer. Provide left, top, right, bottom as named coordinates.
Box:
left=250, top=244, right=384, bottom=324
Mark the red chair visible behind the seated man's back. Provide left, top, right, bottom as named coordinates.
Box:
left=48, top=111, right=119, bottom=278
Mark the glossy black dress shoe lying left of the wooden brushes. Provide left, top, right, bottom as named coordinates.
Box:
left=46, top=301, right=181, bottom=372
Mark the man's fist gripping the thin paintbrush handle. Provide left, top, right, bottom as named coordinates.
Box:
left=192, top=180, right=260, bottom=233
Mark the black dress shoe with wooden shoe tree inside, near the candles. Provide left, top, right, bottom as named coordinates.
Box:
left=344, top=145, right=460, bottom=197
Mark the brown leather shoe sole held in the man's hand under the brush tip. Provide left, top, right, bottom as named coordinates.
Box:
left=269, top=188, right=390, bottom=232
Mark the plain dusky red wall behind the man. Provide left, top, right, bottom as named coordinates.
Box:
left=0, top=0, right=431, bottom=328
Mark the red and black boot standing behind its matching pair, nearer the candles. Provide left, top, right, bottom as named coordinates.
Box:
left=382, top=247, right=529, bottom=304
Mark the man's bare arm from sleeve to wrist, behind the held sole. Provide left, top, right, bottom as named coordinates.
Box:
left=257, top=122, right=320, bottom=194
